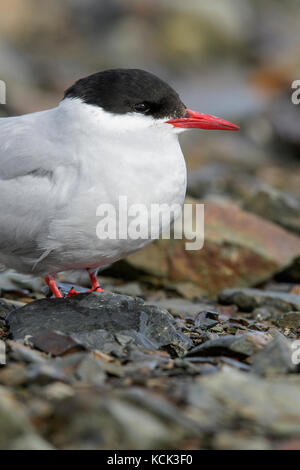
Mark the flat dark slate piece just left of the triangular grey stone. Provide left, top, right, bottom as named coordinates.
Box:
left=187, top=333, right=269, bottom=359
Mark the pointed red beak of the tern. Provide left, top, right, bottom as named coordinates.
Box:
left=166, top=109, right=240, bottom=131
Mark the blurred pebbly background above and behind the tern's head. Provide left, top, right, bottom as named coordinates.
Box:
left=0, top=0, right=300, bottom=196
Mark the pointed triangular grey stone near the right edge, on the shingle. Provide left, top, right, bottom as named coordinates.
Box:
left=251, top=334, right=296, bottom=375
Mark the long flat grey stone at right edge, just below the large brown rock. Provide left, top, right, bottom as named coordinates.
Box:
left=219, top=289, right=300, bottom=312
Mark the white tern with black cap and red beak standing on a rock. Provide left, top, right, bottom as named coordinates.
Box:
left=0, top=69, right=239, bottom=297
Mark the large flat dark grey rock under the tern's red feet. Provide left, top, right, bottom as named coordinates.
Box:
left=7, top=293, right=191, bottom=354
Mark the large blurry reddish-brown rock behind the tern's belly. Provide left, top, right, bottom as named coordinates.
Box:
left=119, top=201, right=300, bottom=297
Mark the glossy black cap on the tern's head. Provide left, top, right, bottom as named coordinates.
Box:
left=64, top=69, right=186, bottom=119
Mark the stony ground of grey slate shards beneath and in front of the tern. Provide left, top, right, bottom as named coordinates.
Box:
left=0, top=272, right=300, bottom=449
